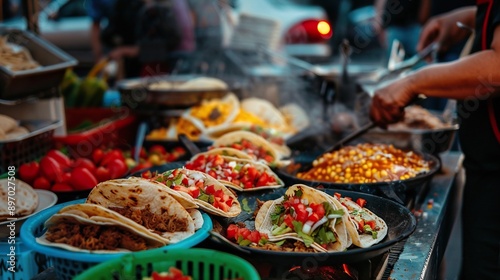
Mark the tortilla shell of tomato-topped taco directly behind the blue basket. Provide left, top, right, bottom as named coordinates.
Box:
left=157, top=168, right=241, bottom=217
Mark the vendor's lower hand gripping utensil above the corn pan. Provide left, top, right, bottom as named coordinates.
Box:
left=370, top=77, right=417, bottom=128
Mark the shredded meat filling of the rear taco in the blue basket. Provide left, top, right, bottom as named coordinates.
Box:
left=109, top=205, right=189, bottom=233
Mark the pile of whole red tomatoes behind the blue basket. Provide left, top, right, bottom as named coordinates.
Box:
left=19, top=149, right=128, bottom=192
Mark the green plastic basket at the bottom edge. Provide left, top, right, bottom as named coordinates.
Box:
left=74, top=248, right=260, bottom=280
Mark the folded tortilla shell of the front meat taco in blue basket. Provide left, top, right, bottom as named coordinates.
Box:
left=36, top=203, right=166, bottom=253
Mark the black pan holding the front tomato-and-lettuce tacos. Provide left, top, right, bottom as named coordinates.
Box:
left=210, top=188, right=417, bottom=267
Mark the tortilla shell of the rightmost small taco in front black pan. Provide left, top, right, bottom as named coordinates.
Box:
left=334, top=197, right=387, bottom=248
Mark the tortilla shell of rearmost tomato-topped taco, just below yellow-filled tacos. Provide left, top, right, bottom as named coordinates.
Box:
left=211, top=131, right=281, bottom=164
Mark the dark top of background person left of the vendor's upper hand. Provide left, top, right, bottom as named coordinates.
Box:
left=382, top=0, right=420, bottom=27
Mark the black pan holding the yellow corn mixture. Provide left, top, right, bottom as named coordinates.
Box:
left=275, top=154, right=441, bottom=204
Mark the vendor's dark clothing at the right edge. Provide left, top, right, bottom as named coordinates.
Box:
left=457, top=0, right=500, bottom=280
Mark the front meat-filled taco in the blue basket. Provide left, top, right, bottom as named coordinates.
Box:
left=36, top=203, right=166, bottom=253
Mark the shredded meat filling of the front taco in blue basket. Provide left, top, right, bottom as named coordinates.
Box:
left=46, top=223, right=148, bottom=251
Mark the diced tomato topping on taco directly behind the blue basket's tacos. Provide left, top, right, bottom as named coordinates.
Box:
left=154, top=168, right=233, bottom=212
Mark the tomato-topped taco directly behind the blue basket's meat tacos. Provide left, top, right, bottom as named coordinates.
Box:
left=152, top=168, right=241, bottom=217
